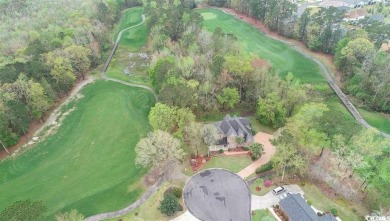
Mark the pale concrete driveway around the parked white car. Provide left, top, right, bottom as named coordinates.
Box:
left=251, top=184, right=304, bottom=211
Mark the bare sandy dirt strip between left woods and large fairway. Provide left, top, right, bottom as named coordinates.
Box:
left=0, top=76, right=95, bottom=160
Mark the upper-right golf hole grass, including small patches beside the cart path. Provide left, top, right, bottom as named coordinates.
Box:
left=198, top=8, right=390, bottom=133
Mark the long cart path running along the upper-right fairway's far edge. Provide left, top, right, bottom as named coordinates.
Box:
left=219, top=7, right=390, bottom=138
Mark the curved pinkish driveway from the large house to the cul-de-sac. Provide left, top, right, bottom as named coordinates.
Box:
left=238, top=132, right=275, bottom=179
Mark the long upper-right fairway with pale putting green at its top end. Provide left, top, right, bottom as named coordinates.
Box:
left=199, top=9, right=326, bottom=83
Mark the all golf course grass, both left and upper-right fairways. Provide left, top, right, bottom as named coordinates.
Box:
left=0, top=4, right=390, bottom=220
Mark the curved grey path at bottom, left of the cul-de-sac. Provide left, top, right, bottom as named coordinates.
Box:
left=85, top=177, right=165, bottom=221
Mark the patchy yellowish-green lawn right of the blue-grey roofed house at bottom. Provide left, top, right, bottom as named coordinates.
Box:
left=301, top=184, right=368, bottom=221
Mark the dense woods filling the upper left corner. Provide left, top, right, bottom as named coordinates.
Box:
left=0, top=0, right=141, bottom=146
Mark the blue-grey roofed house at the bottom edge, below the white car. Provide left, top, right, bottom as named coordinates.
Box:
left=279, top=193, right=337, bottom=221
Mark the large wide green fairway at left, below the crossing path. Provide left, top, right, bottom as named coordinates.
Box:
left=0, top=81, right=154, bottom=220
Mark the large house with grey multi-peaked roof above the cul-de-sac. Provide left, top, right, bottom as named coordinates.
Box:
left=209, top=115, right=253, bottom=151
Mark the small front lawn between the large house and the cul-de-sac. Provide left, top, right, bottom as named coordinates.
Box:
left=201, top=155, right=252, bottom=173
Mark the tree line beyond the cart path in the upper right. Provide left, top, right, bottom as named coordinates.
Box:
left=208, top=0, right=390, bottom=113
